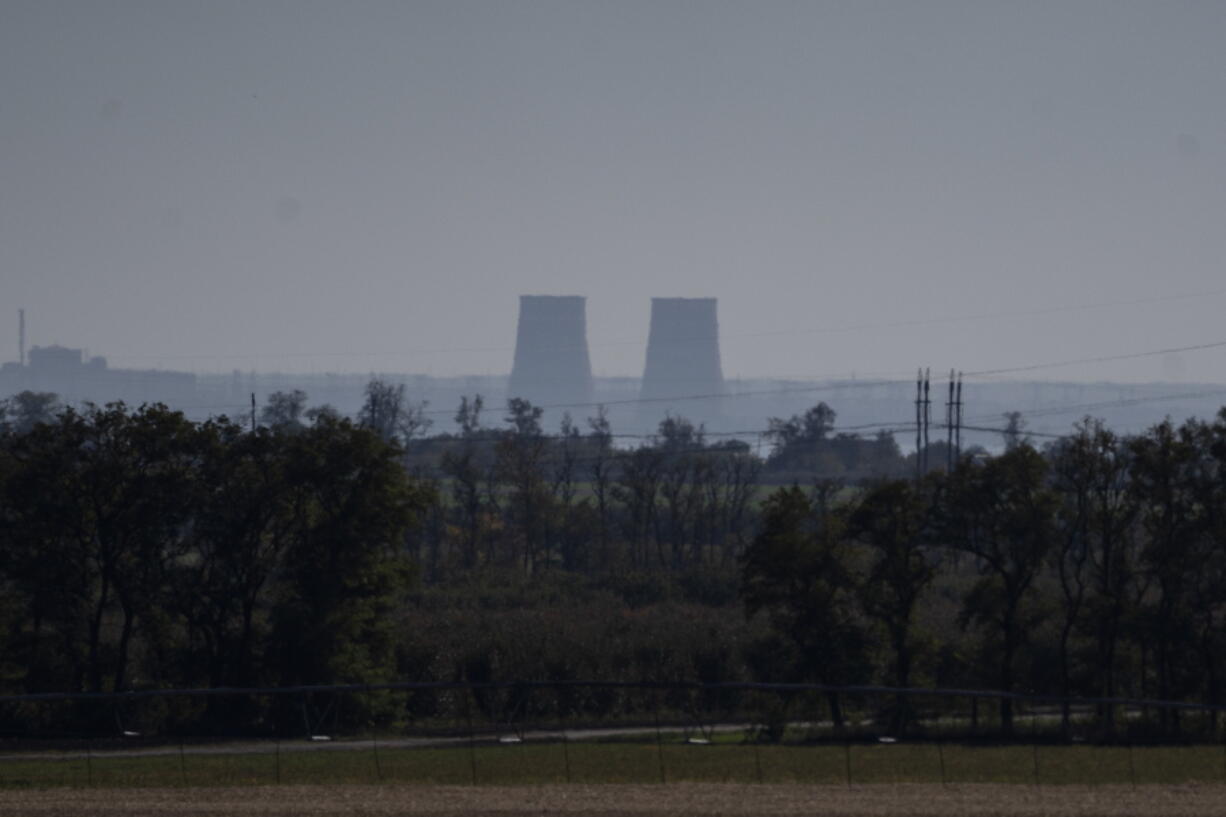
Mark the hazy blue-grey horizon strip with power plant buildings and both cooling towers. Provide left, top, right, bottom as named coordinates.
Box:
left=7, top=301, right=1221, bottom=448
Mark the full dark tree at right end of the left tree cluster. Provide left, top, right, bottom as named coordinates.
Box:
left=273, top=420, right=429, bottom=685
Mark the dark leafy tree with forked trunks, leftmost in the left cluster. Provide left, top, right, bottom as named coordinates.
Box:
left=1, top=404, right=195, bottom=692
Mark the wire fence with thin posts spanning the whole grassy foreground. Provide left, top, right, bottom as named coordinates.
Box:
left=0, top=682, right=1226, bottom=786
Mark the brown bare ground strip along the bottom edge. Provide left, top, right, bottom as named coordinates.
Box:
left=0, top=784, right=1226, bottom=817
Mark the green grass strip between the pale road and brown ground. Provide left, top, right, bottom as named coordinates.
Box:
left=0, top=740, right=1226, bottom=789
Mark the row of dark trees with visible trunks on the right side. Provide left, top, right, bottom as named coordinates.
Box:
left=743, top=410, right=1226, bottom=731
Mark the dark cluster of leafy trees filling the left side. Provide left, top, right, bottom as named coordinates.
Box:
left=0, top=395, right=427, bottom=692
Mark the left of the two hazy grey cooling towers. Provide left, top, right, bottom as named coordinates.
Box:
left=508, top=296, right=592, bottom=406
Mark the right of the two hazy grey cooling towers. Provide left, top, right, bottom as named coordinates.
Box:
left=641, top=298, right=723, bottom=404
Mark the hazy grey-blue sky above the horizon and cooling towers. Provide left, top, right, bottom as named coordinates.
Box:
left=0, top=0, right=1226, bottom=382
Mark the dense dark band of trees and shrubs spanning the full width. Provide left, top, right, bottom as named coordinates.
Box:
left=0, top=382, right=1226, bottom=729
